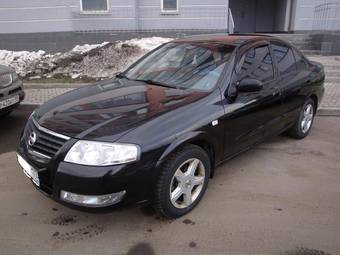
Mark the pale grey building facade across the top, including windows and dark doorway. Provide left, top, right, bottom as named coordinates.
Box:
left=0, top=0, right=340, bottom=34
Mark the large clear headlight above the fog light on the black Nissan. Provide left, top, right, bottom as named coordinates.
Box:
left=65, top=141, right=140, bottom=166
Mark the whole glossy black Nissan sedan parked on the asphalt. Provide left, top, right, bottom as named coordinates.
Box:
left=18, top=35, right=325, bottom=218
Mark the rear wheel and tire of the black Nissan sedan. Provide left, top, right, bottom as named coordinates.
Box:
left=288, top=98, right=315, bottom=139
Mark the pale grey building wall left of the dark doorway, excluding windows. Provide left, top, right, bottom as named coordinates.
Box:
left=0, top=0, right=228, bottom=34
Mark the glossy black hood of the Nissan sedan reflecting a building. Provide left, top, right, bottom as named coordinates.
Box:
left=34, top=79, right=206, bottom=142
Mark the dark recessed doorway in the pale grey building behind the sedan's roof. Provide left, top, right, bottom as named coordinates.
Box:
left=229, top=0, right=289, bottom=33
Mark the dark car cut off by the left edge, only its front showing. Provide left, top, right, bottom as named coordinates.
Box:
left=0, top=65, right=25, bottom=117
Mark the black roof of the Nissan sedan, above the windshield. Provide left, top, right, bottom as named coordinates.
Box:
left=175, top=34, right=287, bottom=46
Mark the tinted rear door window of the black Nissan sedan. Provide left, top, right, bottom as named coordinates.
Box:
left=272, top=43, right=296, bottom=75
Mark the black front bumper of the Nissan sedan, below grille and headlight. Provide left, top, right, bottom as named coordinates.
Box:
left=18, top=140, right=154, bottom=208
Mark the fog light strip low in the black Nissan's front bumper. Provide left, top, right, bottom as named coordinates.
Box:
left=60, top=190, right=126, bottom=207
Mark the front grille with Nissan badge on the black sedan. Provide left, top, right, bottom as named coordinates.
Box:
left=25, top=118, right=69, bottom=158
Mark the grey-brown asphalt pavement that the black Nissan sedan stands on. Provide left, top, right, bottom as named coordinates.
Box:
left=0, top=111, right=340, bottom=255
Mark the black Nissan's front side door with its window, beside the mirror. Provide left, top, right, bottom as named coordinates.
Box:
left=224, top=42, right=281, bottom=157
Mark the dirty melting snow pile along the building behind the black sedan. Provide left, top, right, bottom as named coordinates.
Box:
left=0, top=37, right=172, bottom=79
